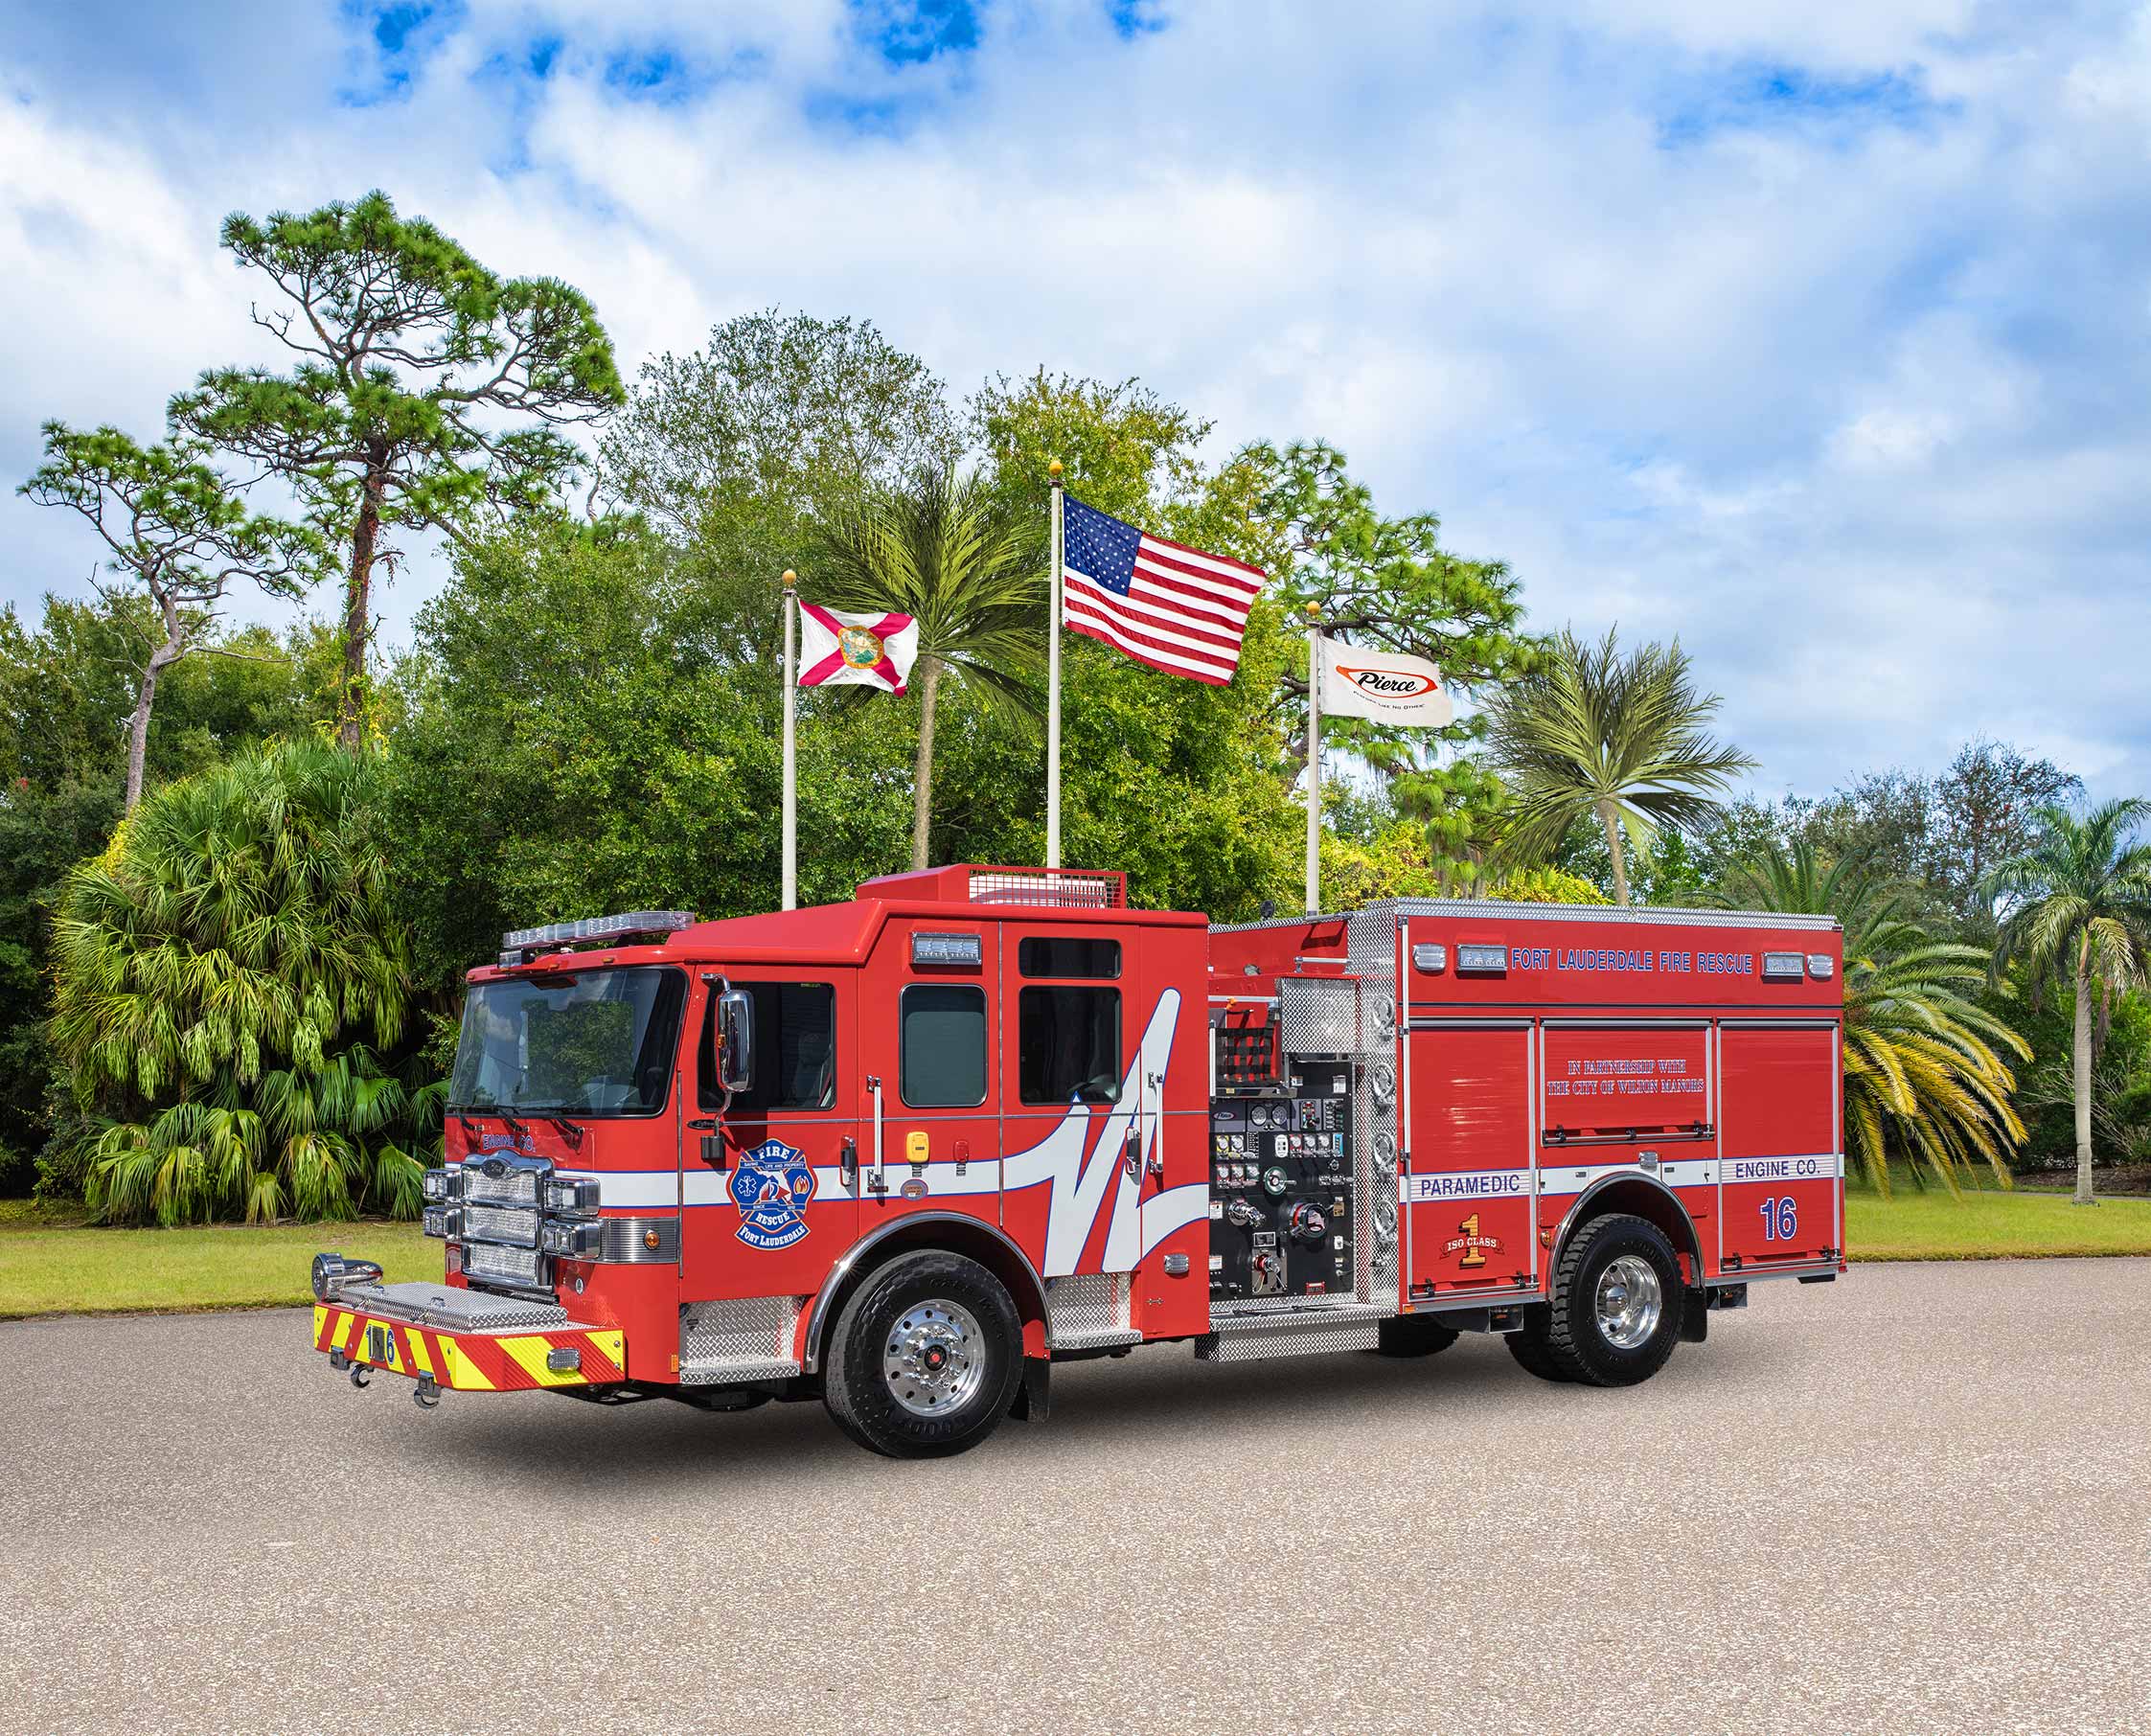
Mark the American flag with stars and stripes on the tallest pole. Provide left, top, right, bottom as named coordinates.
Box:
left=1061, top=494, right=1265, bottom=686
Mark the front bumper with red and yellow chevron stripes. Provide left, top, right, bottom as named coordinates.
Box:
left=314, top=1284, right=629, bottom=1392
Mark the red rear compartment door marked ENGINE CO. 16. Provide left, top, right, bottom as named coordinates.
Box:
left=1719, top=1019, right=1843, bottom=1271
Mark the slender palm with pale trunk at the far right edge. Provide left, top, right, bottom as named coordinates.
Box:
left=1983, top=798, right=2151, bottom=1204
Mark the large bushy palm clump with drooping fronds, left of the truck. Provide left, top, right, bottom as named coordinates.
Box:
left=52, top=742, right=439, bottom=1224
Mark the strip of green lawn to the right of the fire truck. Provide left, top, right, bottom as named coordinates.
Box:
left=1845, top=1178, right=2151, bottom=1261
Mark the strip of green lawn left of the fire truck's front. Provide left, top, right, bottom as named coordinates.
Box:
left=0, top=1200, right=441, bottom=1318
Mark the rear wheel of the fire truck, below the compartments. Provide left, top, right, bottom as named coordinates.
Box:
left=1548, top=1218, right=1684, bottom=1385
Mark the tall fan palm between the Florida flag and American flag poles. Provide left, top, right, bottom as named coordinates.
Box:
left=813, top=467, right=1045, bottom=869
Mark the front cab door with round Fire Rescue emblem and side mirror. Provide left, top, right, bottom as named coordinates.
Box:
left=679, top=966, right=860, bottom=1299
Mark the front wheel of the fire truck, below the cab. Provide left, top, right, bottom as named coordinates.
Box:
left=822, top=1254, right=1024, bottom=1458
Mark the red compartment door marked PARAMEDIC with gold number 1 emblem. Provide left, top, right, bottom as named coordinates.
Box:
left=1400, top=1019, right=1538, bottom=1299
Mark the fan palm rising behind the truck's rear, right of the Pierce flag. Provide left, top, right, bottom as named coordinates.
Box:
left=1486, top=628, right=1755, bottom=903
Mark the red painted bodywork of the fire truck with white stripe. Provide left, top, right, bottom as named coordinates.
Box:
left=427, top=867, right=1843, bottom=1382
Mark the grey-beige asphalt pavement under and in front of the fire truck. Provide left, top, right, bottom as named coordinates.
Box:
left=0, top=1261, right=2151, bottom=1736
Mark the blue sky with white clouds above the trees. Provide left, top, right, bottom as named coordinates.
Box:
left=0, top=0, right=2151, bottom=794
